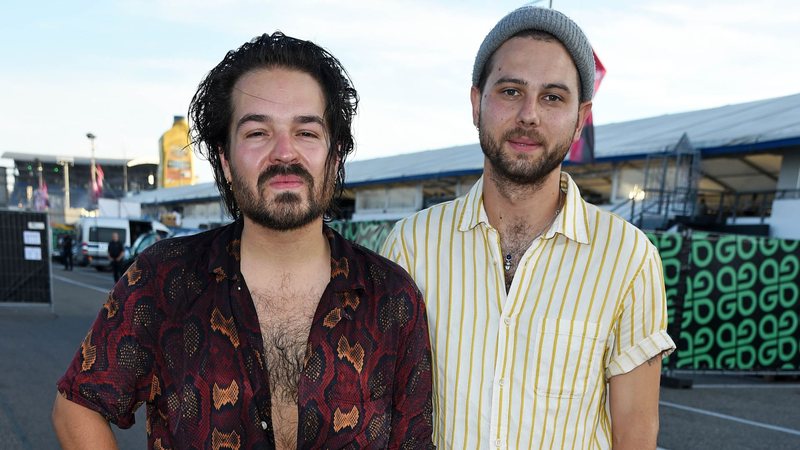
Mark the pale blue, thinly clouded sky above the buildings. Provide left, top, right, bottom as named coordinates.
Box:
left=0, top=0, right=800, bottom=180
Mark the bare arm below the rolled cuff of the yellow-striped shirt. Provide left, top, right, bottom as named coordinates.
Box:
left=608, top=355, right=661, bottom=450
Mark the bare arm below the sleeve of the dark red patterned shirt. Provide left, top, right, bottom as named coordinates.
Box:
left=52, top=393, right=117, bottom=450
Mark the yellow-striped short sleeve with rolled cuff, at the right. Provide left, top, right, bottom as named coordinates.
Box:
left=605, top=241, right=675, bottom=378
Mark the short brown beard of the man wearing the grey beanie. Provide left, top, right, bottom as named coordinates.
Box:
left=478, top=114, right=577, bottom=188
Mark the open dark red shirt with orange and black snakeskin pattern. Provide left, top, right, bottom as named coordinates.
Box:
left=58, top=221, right=432, bottom=450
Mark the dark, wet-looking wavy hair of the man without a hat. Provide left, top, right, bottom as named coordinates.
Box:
left=189, top=32, right=358, bottom=219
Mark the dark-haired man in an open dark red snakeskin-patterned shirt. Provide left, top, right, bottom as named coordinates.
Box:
left=53, top=33, right=432, bottom=449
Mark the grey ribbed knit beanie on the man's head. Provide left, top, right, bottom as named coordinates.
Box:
left=472, top=6, right=594, bottom=102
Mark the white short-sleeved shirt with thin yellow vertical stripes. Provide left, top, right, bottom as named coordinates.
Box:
left=383, top=173, right=675, bottom=450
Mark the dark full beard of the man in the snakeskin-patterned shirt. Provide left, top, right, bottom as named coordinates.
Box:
left=231, top=164, right=333, bottom=231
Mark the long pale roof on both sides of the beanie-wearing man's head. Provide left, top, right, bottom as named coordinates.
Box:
left=347, top=94, right=800, bottom=187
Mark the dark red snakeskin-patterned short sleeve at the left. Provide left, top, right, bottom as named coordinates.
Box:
left=57, top=256, right=161, bottom=428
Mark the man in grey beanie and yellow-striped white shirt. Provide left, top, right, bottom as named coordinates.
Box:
left=383, top=6, right=675, bottom=449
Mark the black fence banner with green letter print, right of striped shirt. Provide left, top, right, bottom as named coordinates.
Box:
left=648, top=232, right=800, bottom=372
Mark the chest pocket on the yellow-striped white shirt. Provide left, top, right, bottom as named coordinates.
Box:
left=532, top=319, right=605, bottom=398
